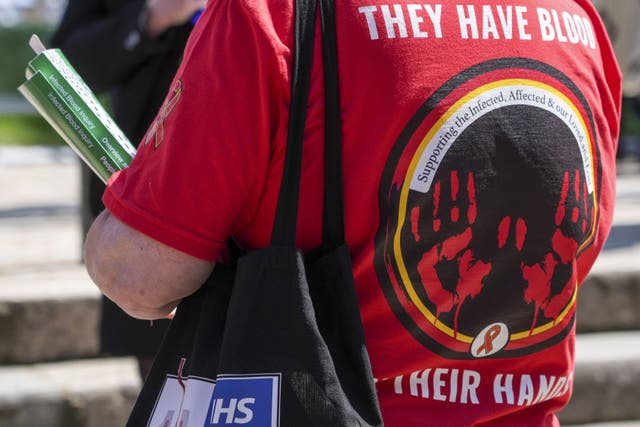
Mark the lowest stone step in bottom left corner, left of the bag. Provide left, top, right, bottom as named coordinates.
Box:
left=0, top=358, right=141, bottom=427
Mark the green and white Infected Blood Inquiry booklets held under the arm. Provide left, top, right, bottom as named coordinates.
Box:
left=18, top=35, right=136, bottom=182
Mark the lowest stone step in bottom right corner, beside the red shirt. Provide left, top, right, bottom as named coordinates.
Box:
left=560, top=331, right=640, bottom=425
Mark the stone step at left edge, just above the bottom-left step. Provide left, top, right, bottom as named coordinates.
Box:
left=0, top=264, right=100, bottom=362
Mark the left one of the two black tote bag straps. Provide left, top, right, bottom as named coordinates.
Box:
left=271, top=0, right=317, bottom=246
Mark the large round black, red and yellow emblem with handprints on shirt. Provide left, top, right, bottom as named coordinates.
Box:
left=375, top=58, right=600, bottom=359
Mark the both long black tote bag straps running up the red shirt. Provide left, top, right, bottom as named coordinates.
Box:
left=271, top=0, right=345, bottom=252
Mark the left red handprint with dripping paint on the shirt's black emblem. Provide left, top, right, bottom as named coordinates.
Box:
left=411, top=171, right=491, bottom=336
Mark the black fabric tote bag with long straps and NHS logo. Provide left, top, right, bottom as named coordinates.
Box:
left=127, top=0, right=382, bottom=427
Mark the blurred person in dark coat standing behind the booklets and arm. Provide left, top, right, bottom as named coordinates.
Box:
left=51, top=0, right=206, bottom=377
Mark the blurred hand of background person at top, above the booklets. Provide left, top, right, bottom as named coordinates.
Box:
left=146, top=0, right=207, bottom=37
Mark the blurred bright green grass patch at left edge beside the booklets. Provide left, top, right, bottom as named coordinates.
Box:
left=0, top=114, right=64, bottom=146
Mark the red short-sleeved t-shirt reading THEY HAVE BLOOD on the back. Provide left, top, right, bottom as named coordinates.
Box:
left=104, top=0, right=620, bottom=427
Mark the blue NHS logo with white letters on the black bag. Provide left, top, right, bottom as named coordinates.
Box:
left=204, top=374, right=281, bottom=427
